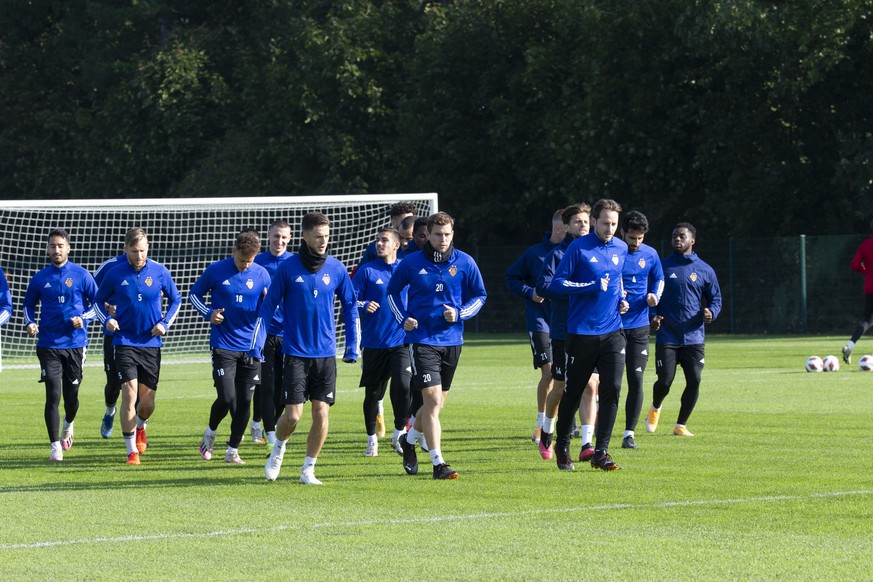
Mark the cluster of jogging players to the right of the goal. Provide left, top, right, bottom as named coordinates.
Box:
left=506, top=199, right=721, bottom=471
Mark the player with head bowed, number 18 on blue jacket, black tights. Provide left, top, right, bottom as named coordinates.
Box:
left=188, top=231, right=270, bottom=465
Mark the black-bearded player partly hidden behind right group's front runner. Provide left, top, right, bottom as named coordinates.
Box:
left=621, top=210, right=664, bottom=449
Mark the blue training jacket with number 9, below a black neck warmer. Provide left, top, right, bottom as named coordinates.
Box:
left=249, top=254, right=358, bottom=360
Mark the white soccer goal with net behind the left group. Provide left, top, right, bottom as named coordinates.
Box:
left=0, top=193, right=438, bottom=370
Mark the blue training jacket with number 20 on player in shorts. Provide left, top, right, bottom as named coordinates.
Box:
left=388, top=249, right=487, bottom=346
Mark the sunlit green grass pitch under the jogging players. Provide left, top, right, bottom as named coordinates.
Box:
left=0, top=335, right=873, bottom=580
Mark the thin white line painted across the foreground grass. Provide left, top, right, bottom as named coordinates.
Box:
left=0, top=490, right=873, bottom=550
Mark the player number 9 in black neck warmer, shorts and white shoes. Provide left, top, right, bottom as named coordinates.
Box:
left=249, top=212, right=358, bottom=485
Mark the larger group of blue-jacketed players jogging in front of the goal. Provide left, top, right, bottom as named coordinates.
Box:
left=13, top=203, right=486, bottom=485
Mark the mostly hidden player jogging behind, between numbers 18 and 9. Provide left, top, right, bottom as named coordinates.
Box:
left=252, top=220, right=293, bottom=447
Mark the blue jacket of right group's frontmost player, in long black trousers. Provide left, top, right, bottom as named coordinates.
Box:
left=549, top=232, right=627, bottom=335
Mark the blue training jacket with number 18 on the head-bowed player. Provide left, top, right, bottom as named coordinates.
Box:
left=188, top=258, right=270, bottom=352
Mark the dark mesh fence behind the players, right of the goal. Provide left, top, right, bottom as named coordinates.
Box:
left=470, top=235, right=865, bottom=338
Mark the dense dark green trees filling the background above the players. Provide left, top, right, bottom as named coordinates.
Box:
left=0, top=0, right=873, bottom=244
